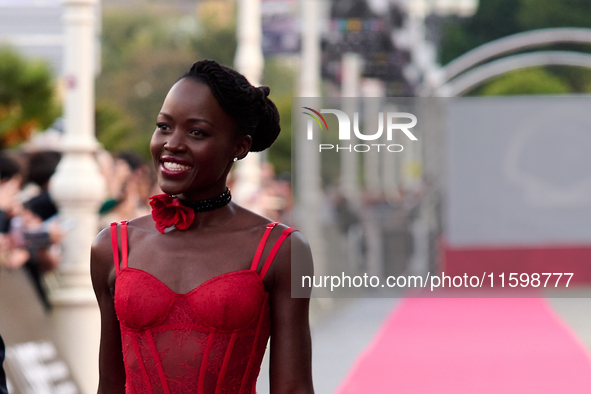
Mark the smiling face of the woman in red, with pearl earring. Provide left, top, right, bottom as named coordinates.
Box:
left=150, top=78, right=250, bottom=200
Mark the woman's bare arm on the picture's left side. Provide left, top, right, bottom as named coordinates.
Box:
left=90, top=229, right=125, bottom=394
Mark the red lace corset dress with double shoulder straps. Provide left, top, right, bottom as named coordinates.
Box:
left=111, top=222, right=293, bottom=394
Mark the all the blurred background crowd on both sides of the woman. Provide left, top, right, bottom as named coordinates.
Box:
left=0, top=150, right=291, bottom=310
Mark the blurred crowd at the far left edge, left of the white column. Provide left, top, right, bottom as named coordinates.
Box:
left=0, top=151, right=64, bottom=309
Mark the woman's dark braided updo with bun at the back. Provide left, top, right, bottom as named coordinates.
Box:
left=180, top=60, right=281, bottom=152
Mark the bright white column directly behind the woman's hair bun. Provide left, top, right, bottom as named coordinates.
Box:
left=232, top=0, right=264, bottom=213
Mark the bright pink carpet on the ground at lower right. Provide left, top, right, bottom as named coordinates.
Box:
left=337, top=298, right=591, bottom=394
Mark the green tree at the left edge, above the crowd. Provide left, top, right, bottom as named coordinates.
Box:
left=0, top=48, right=59, bottom=147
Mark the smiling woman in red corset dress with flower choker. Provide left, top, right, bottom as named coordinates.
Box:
left=91, top=61, right=313, bottom=394
